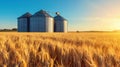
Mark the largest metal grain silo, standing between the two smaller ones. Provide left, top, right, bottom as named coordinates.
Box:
left=30, top=10, right=54, bottom=32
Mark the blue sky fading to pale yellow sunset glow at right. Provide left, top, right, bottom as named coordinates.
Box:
left=0, top=0, right=120, bottom=31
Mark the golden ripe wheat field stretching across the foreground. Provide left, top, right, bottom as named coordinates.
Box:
left=0, top=32, right=120, bottom=67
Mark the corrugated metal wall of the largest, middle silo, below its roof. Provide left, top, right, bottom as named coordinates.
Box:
left=30, top=17, right=54, bottom=32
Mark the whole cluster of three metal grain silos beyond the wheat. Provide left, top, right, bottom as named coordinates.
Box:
left=18, top=10, right=68, bottom=32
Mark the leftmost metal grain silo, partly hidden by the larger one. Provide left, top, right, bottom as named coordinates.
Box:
left=18, top=12, right=31, bottom=32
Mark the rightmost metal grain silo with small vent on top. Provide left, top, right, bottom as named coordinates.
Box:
left=54, top=12, right=68, bottom=32
